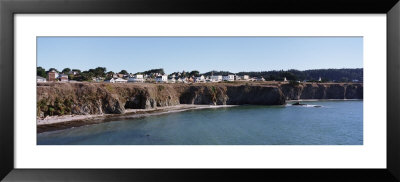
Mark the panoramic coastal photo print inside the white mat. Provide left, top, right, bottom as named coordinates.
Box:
left=36, top=37, right=364, bottom=145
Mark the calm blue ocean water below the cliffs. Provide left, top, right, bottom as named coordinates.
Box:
left=37, top=100, right=363, bottom=145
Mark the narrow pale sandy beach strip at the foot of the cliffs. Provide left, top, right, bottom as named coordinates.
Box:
left=36, top=104, right=236, bottom=133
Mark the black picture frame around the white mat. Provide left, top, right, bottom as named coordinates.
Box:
left=0, top=0, right=400, bottom=181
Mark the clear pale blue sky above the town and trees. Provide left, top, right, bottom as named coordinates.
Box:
left=37, top=37, right=363, bottom=73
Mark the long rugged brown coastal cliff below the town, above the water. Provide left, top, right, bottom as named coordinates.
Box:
left=37, top=83, right=363, bottom=118
